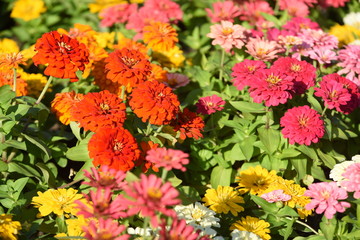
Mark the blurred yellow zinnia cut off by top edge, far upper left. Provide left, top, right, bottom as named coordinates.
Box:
left=10, top=0, right=46, bottom=21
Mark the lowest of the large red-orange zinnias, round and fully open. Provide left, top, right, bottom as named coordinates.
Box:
left=88, top=127, right=140, bottom=171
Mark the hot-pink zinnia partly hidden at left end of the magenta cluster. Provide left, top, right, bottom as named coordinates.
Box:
left=231, top=59, right=266, bottom=91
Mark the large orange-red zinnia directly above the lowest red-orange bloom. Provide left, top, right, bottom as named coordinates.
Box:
left=71, top=90, right=126, bottom=132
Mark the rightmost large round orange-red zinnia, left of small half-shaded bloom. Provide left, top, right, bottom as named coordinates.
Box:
left=129, top=81, right=180, bottom=125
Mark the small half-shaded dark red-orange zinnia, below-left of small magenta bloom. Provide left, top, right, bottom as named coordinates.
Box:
left=171, top=108, right=205, bottom=140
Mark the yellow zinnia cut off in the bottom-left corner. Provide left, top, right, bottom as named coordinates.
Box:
left=0, top=213, right=21, bottom=240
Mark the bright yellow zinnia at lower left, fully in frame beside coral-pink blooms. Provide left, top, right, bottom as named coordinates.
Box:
left=32, top=188, right=83, bottom=217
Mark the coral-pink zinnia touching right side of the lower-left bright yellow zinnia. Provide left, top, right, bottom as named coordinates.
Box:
left=75, top=188, right=127, bottom=219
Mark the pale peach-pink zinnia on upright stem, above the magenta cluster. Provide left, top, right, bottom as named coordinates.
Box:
left=206, top=21, right=246, bottom=52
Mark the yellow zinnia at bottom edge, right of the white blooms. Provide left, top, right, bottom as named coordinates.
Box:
left=230, top=216, right=271, bottom=240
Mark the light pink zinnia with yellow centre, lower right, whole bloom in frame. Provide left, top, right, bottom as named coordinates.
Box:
left=304, top=182, right=352, bottom=219
